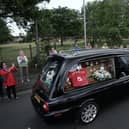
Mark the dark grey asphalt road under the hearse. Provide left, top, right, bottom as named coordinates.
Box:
left=0, top=91, right=129, bottom=129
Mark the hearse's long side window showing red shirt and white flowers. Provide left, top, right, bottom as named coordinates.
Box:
left=64, top=58, right=115, bottom=91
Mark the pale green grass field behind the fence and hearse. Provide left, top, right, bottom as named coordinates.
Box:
left=0, top=41, right=88, bottom=65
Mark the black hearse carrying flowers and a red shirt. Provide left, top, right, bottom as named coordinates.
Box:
left=31, top=49, right=129, bottom=123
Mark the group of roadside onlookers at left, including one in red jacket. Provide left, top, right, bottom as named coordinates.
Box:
left=0, top=50, right=30, bottom=100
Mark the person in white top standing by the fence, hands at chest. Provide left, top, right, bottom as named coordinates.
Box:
left=17, top=50, right=30, bottom=84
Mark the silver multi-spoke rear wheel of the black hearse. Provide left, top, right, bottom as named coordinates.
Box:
left=80, top=102, right=98, bottom=124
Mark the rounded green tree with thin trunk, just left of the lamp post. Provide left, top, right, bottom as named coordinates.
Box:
left=51, top=7, right=83, bottom=45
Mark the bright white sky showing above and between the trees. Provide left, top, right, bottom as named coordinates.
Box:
left=7, top=0, right=95, bottom=36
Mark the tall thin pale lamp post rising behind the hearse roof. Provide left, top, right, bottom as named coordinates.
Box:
left=83, top=0, right=87, bottom=47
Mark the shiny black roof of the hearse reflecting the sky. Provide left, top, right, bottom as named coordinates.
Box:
left=53, top=49, right=129, bottom=59
